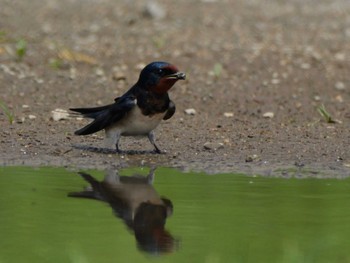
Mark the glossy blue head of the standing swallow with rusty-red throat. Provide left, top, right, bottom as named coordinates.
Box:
left=138, top=62, right=186, bottom=94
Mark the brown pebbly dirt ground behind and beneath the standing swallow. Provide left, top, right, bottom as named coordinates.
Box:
left=0, top=0, right=350, bottom=177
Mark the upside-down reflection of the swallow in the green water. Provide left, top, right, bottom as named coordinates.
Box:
left=68, top=168, right=178, bottom=254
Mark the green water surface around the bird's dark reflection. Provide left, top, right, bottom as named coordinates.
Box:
left=0, top=167, right=350, bottom=263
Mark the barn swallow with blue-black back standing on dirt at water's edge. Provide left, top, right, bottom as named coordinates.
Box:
left=70, top=62, right=186, bottom=153
